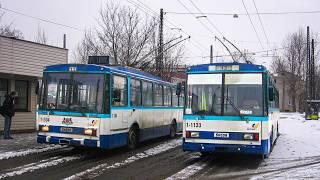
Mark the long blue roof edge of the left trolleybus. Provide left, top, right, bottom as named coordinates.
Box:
left=44, top=64, right=172, bottom=84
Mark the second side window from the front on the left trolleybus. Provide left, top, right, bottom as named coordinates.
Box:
left=130, top=79, right=142, bottom=106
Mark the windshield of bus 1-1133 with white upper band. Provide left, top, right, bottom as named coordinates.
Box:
left=185, top=73, right=263, bottom=116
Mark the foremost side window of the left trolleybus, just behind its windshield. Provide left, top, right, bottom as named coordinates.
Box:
left=112, top=76, right=128, bottom=106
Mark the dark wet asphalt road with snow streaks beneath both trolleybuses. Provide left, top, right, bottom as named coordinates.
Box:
left=0, top=137, right=263, bottom=179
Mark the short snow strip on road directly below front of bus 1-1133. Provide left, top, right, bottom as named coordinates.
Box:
left=166, top=162, right=208, bottom=180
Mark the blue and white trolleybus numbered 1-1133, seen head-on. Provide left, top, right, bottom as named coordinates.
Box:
left=183, top=63, right=279, bottom=157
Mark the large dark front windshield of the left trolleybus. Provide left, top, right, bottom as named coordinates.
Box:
left=40, top=73, right=105, bottom=113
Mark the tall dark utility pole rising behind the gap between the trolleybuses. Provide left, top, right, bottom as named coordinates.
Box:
left=156, top=8, right=163, bottom=77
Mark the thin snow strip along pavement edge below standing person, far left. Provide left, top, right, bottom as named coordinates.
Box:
left=0, top=145, right=64, bottom=160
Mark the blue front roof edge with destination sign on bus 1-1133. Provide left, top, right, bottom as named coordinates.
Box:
left=187, top=62, right=267, bottom=74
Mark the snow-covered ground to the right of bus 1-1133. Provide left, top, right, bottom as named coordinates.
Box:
left=252, top=113, right=320, bottom=179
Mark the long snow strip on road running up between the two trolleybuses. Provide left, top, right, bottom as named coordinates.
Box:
left=64, top=139, right=181, bottom=180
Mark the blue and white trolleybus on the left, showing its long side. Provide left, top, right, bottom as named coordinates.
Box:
left=37, top=64, right=184, bottom=149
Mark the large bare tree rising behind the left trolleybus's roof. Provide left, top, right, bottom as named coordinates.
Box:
left=74, top=1, right=183, bottom=79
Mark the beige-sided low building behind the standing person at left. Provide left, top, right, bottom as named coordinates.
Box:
left=0, top=36, right=68, bottom=133
